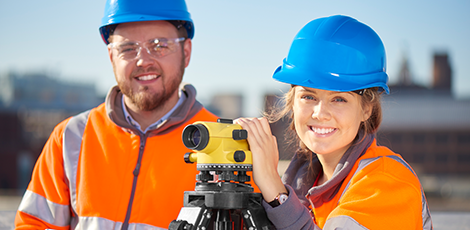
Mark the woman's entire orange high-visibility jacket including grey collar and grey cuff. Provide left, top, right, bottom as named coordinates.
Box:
left=263, top=137, right=432, bottom=230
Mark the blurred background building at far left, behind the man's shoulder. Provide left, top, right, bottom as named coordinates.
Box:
left=0, top=72, right=103, bottom=190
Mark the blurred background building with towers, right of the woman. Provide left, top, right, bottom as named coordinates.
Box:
left=378, top=52, right=470, bottom=175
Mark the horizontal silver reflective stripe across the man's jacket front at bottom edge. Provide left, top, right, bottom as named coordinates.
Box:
left=76, top=217, right=165, bottom=230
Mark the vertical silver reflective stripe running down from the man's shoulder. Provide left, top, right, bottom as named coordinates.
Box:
left=62, top=110, right=90, bottom=229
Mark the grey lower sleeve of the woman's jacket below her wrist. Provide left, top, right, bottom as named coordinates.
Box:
left=263, top=185, right=321, bottom=230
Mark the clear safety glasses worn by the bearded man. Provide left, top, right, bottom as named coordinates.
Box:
left=108, top=37, right=186, bottom=61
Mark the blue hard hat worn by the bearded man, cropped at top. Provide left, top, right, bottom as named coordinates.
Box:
left=100, top=0, right=194, bottom=44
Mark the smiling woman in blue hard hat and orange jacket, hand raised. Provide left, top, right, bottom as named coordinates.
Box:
left=236, top=15, right=432, bottom=229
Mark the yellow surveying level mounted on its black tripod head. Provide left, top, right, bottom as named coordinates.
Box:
left=168, top=119, right=275, bottom=230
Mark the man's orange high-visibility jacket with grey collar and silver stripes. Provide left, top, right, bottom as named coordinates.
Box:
left=15, top=85, right=217, bottom=229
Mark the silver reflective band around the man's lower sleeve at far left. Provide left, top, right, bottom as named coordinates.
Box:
left=18, top=190, right=70, bottom=227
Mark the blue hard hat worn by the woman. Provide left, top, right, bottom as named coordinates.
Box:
left=273, top=15, right=389, bottom=93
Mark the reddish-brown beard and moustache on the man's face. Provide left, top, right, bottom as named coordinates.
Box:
left=118, top=57, right=185, bottom=111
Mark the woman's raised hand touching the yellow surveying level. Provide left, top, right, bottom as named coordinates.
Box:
left=234, top=117, right=287, bottom=202
